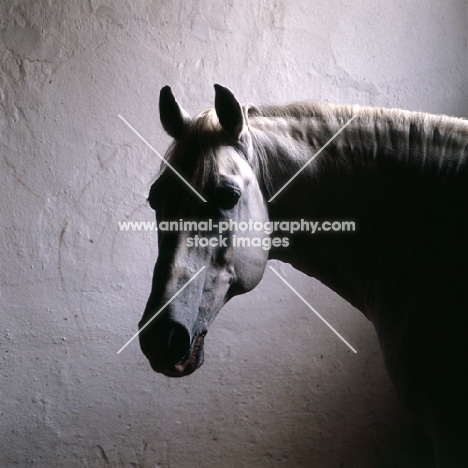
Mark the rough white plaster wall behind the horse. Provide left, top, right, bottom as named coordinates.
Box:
left=0, top=0, right=468, bottom=468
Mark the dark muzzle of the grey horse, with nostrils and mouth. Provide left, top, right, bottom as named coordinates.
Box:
left=139, top=322, right=206, bottom=377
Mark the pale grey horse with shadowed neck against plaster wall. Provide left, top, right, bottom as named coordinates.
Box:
left=138, top=85, right=468, bottom=468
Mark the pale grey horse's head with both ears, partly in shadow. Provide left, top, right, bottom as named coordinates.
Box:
left=139, top=85, right=268, bottom=377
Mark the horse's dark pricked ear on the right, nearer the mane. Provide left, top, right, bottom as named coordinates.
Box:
left=214, top=84, right=245, bottom=140
